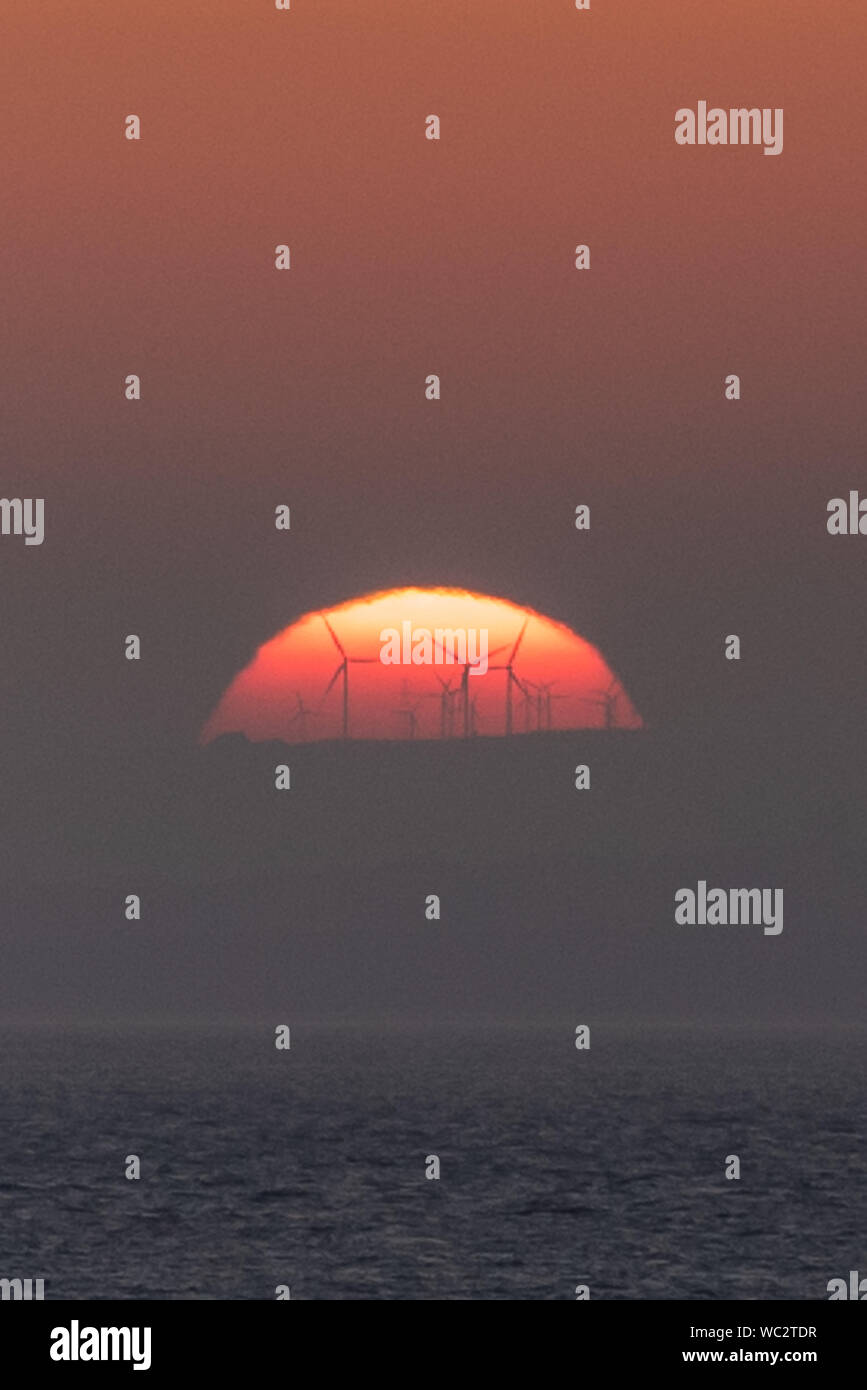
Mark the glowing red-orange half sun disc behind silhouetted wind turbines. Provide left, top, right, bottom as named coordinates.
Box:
left=200, top=589, right=642, bottom=744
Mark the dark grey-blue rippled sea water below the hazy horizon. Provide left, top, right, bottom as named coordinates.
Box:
left=0, top=1024, right=867, bottom=1300
